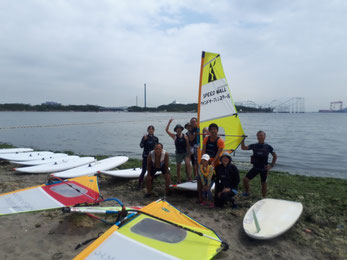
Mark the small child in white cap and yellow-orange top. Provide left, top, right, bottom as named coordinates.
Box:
left=199, top=154, right=215, bottom=208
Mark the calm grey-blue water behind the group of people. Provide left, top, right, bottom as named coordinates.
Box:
left=0, top=112, right=347, bottom=178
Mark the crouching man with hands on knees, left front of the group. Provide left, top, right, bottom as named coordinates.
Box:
left=145, top=143, right=171, bottom=197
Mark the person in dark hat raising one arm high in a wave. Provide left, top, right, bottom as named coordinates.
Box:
left=165, top=119, right=192, bottom=183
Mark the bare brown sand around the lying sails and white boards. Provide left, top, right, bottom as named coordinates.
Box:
left=0, top=162, right=342, bottom=259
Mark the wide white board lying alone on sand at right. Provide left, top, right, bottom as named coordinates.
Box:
left=243, top=199, right=303, bottom=240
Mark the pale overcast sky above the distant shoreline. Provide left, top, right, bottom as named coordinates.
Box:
left=0, top=0, right=347, bottom=111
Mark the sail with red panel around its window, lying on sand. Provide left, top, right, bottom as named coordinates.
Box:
left=0, top=176, right=99, bottom=215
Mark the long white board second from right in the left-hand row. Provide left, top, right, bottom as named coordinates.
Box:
left=51, top=156, right=129, bottom=178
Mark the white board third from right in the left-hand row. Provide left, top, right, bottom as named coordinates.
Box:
left=14, top=157, right=95, bottom=173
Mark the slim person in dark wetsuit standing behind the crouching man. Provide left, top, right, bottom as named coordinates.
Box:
left=138, top=125, right=159, bottom=189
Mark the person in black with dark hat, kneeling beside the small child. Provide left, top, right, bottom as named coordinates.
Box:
left=214, top=153, right=240, bottom=208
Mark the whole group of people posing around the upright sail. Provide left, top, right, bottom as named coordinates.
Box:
left=138, top=117, right=277, bottom=207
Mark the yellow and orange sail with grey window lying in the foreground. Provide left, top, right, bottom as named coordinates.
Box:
left=75, top=200, right=227, bottom=259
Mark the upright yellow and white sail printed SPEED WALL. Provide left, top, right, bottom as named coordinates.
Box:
left=198, top=52, right=244, bottom=158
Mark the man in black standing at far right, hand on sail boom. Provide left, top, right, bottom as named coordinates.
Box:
left=241, top=131, right=277, bottom=198
